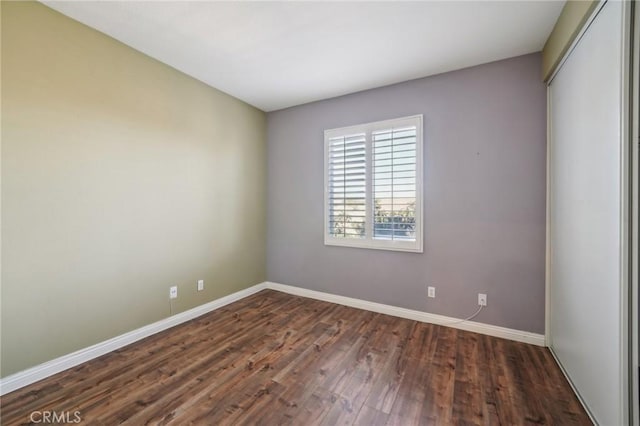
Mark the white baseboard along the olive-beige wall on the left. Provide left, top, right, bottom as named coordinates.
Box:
left=0, top=283, right=266, bottom=395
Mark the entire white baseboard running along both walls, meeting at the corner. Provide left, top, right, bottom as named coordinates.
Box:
left=0, top=281, right=545, bottom=395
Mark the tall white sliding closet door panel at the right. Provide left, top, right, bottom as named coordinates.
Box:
left=549, top=1, right=626, bottom=425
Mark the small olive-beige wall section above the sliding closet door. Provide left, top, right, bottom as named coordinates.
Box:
left=542, top=0, right=599, bottom=81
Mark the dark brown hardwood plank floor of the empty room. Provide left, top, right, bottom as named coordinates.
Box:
left=0, top=290, right=591, bottom=426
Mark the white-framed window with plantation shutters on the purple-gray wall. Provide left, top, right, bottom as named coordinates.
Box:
left=324, top=115, right=422, bottom=252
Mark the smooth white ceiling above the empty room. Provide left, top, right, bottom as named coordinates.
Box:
left=43, top=1, right=564, bottom=111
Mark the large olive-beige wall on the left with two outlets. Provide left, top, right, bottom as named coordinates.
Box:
left=1, top=2, right=266, bottom=376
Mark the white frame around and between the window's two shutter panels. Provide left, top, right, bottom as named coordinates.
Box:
left=324, top=114, right=424, bottom=253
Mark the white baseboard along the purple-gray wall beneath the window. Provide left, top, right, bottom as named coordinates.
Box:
left=264, top=281, right=545, bottom=346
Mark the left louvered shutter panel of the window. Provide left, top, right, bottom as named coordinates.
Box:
left=328, top=133, right=366, bottom=238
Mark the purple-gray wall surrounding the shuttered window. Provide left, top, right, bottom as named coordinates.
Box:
left=267, top=53, right=546, bottom=333
